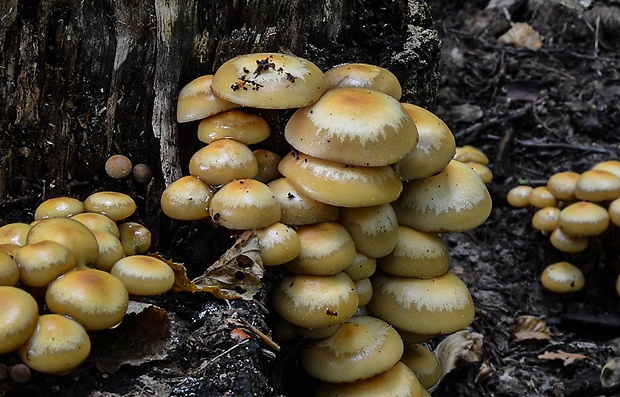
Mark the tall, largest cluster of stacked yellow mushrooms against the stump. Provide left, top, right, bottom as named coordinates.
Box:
left=172, top=53, right=491, bottom=396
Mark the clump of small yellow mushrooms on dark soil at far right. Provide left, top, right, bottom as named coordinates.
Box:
left=507, top=160, right=620, bottom=295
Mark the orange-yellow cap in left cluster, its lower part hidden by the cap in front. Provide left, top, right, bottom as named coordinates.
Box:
left=26, top=218, right=99, bottom=266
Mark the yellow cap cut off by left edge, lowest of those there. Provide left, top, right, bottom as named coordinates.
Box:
left=0, top=286, right=39, bottom=354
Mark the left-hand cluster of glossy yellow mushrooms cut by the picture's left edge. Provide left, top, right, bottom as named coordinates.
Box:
left=0, top=191, right=174, bottom=375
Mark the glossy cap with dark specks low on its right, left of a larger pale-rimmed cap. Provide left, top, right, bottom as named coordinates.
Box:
left=271, top=273, right=358, bottom=329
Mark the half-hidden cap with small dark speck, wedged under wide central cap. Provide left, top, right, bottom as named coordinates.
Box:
left=267, top=177, right=338, bottom=226
